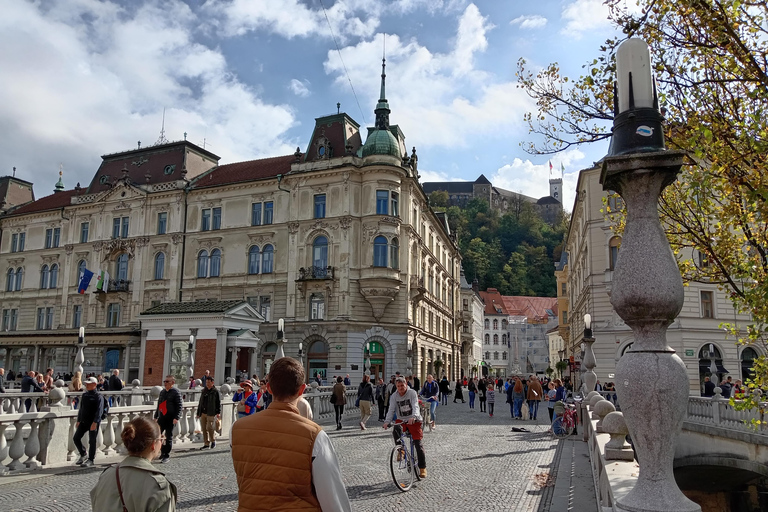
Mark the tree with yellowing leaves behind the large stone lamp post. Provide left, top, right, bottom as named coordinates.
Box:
left=518, top=0, right=768, bottom=406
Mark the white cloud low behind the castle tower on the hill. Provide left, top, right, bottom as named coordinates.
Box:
left=488, top=149, right=585, bottom=211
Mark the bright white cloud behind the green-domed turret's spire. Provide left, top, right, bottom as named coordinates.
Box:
left=325, top=4, right=535, bottom=149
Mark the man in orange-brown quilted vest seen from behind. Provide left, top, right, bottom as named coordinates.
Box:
left=231, top=357, right=352, bottom=512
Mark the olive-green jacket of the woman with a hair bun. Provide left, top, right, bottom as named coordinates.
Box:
left=91, top=456, right=176, bottom=512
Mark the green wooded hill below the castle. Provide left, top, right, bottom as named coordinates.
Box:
left=429, top=191, right=569, bottom=297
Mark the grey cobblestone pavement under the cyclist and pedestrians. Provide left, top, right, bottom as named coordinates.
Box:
left=0, top=402, right=559, bottom=512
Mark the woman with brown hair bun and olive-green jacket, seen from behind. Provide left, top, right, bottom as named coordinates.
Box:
left=91, top=416, right=177, bottom=512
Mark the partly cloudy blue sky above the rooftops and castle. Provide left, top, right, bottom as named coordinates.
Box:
left=0, top=0, right=628, bottom=211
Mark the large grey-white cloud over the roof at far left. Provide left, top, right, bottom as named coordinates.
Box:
left=0, top=0, right=295, bottom=188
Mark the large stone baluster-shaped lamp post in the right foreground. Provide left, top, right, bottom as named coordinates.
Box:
left=600, top=38, right=701, bottom=512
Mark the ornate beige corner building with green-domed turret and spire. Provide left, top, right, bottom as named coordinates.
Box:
left=0, top=62, right=463, bottom=385
